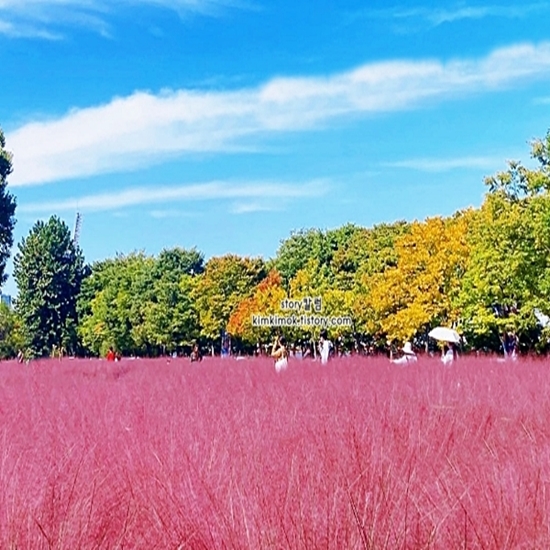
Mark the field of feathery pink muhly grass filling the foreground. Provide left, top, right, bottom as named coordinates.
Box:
left=0, top=357, right=550, bottom=549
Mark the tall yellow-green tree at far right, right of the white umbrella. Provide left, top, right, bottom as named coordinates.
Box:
left=458, top=132, right=550, bottom=349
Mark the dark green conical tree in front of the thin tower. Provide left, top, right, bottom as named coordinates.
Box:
left=14, top=216, right=85, bottom=356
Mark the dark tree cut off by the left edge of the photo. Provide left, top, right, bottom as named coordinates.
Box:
left=0, top=129, right=16, bottom=285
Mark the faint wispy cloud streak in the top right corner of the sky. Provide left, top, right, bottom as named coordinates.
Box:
left=353, top=2, right=550, bottom=27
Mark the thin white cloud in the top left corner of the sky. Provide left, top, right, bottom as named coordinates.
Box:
left=0, top=0, right=245, bottom=39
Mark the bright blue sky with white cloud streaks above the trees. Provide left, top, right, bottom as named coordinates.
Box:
left=0, top=0, right=550, bottom=294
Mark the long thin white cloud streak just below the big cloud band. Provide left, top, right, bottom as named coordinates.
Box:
left=18, top=180, right=330, bottom=217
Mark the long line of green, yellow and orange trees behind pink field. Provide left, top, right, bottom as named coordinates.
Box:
left=0, top=127, right=550, bottom=357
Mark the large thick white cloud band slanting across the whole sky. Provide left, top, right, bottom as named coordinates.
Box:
left=7, top=42, right=550, bottom=186
